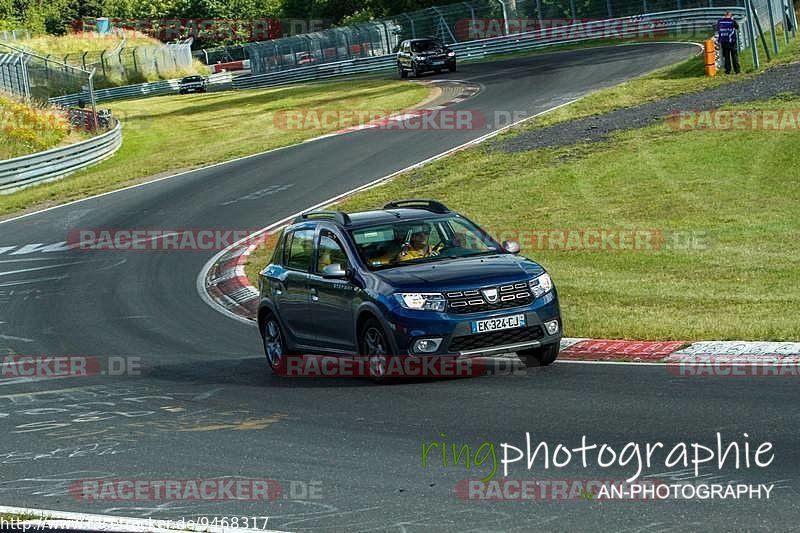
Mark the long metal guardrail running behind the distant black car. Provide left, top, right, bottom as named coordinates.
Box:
left=233, top=6, right=745, bottom=89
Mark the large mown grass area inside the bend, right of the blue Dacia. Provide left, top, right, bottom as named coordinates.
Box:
left=248, top=95, right=800, bottom=340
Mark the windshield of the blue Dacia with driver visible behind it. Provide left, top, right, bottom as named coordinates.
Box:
left=350, top=216, right=502, bottom=270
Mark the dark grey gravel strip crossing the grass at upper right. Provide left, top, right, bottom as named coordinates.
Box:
left=496, top=63, right=800, bottom=152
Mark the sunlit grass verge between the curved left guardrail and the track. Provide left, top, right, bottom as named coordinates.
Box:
left=0, top=80, right=430, bottom=216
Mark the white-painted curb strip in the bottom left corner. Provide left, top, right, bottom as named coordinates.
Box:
left=0, top=505, right=282, bottom=533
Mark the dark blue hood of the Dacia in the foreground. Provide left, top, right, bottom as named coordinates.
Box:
left=375, top=254, right=544, bottom=292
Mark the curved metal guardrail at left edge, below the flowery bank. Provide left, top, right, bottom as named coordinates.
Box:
left=0, top=120, right=122, bottom=194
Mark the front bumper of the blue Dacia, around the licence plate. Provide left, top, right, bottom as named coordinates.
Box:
left=386, top=292, right=563, bottom=357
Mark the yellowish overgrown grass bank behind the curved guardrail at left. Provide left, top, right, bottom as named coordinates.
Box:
left=0, top=94, right=86, bottom=160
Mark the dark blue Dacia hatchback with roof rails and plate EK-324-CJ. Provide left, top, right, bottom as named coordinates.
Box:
left=258, top=200, right=562, bottom=379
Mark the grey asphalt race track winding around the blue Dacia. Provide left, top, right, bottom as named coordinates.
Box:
left=0, top=44, right=800, bottom=531
